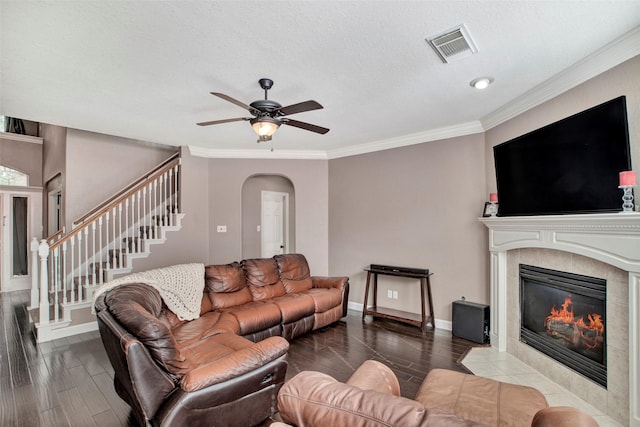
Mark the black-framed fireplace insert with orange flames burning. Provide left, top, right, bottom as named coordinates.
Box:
left=520, top=264, right=607, bottom=387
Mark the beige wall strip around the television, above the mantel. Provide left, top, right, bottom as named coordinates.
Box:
left=485, top=56, right=640, bottom=191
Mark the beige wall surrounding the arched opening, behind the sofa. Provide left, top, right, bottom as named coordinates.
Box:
left=209, top=159, right=329, bottom=275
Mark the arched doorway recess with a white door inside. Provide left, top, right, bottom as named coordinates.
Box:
left=242, top=174, right=295, bottom=259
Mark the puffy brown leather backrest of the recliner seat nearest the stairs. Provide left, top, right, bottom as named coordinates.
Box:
left=104, top=283, right=188, bottom=375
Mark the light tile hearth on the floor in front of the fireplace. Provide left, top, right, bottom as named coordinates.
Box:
left=462, top=347, right=622, bottom=427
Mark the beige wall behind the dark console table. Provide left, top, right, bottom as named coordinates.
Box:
left=328, top=134, right=489, bottom=320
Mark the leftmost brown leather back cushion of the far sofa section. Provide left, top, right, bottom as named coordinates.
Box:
left=204, top=262, right=252, bottom=310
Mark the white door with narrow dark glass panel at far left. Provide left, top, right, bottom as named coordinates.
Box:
left=0, top=190, right=42, bottom=292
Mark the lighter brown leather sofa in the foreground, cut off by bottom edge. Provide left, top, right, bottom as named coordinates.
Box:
left=271, top=360, right=598, bottom=427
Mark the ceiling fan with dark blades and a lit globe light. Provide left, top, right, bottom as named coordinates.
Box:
left=196, top=79, right=329, bottom=142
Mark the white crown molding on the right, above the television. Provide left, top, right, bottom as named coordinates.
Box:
left=480, top=26, right=640, bottom=130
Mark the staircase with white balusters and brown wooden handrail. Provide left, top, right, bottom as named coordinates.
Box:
left=29, top=154, right=184, bottom=342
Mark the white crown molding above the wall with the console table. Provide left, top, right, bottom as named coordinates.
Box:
left=327, top=120, right=485, bottom=159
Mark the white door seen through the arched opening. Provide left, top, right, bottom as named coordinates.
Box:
left=261, top=191, right=289, bottom=258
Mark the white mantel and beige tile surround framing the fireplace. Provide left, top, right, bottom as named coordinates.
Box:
left=482, top=213, right=640, bottom=427
